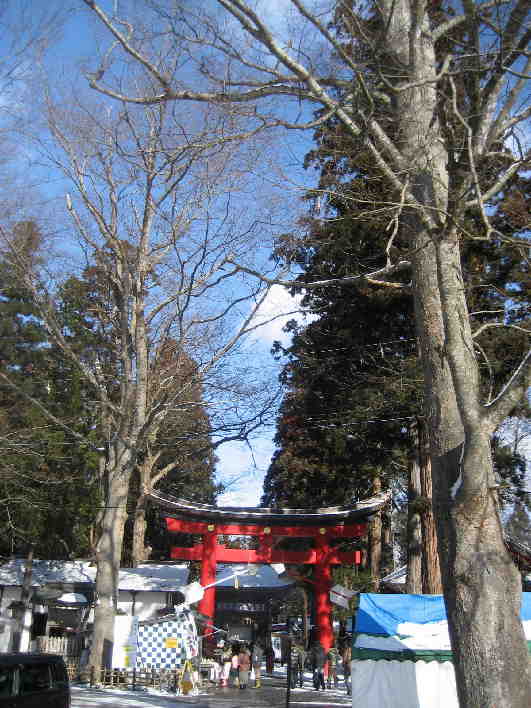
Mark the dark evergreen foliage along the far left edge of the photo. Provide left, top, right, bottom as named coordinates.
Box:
left=0, top=222, right=97, bottom=558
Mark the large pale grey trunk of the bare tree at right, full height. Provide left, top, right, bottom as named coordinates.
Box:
left=385, top=0, right=531, bottom=708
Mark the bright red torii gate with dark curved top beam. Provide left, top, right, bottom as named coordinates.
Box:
left=150, top=492, right=388, bottom=650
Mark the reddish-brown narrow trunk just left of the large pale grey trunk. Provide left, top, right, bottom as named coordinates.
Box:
left=417, top=418, right=443, bottom=595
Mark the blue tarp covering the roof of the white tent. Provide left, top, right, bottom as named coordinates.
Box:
left=354, top=592, right=531, bottom=636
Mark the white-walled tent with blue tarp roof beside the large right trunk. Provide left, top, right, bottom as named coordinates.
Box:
left=352, top=593, right=531, bottom=708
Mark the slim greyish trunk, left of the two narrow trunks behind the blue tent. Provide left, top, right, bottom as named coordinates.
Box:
left=406, top=424, right=422, bottom=595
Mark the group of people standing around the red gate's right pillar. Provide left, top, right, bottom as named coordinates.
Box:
left=291, top=641, right=352, bottom=695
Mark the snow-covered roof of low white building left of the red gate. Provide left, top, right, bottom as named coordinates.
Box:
left=0, top=559, right=188, bottom=592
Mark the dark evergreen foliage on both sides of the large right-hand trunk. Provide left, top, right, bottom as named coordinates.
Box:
left=262, top=58, right=530, bottom=506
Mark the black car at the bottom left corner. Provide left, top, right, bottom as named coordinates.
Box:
left=0, top=653, right=70, bottom=708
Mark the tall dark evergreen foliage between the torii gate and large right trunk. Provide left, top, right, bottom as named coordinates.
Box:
left=263, top=129, right=420, bottom=506
